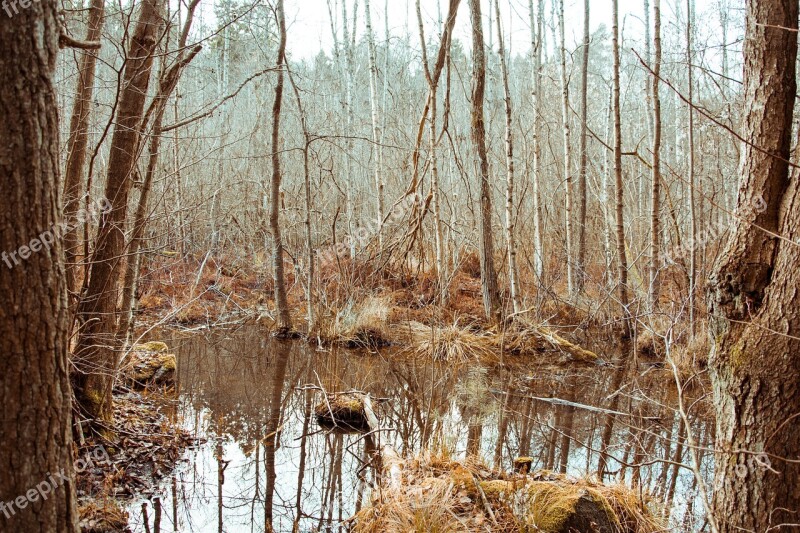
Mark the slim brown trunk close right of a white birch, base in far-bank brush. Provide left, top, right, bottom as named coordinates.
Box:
left=575, top=0, right=591, bottom=293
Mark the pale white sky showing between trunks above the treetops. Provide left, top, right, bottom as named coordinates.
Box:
left=285, top=0, right=732, bottom=60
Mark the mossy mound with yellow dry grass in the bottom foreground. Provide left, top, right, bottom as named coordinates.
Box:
left=353, top=457, right=664, bottom=533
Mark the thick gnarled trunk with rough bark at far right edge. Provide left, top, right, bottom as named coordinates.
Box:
left=708, top=0, right=800, bottom=533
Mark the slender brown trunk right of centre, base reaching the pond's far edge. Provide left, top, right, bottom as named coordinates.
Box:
left=611, top=0, right=630, bottom=337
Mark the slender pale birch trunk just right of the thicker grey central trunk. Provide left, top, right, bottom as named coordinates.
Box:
left=494, top=2, right=522, bottom=313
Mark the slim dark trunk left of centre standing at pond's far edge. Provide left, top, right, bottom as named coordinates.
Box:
left=269, top=0, right=292, bottom=335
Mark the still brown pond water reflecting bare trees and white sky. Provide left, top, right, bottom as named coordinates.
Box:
left=125, top=327, right=713, bottom=532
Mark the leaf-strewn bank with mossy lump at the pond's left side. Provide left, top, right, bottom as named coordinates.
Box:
left=75, top=343, right=197, bottom=533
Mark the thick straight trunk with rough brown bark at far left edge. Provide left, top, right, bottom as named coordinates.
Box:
left=0, top=0, right=78, bottom=533
